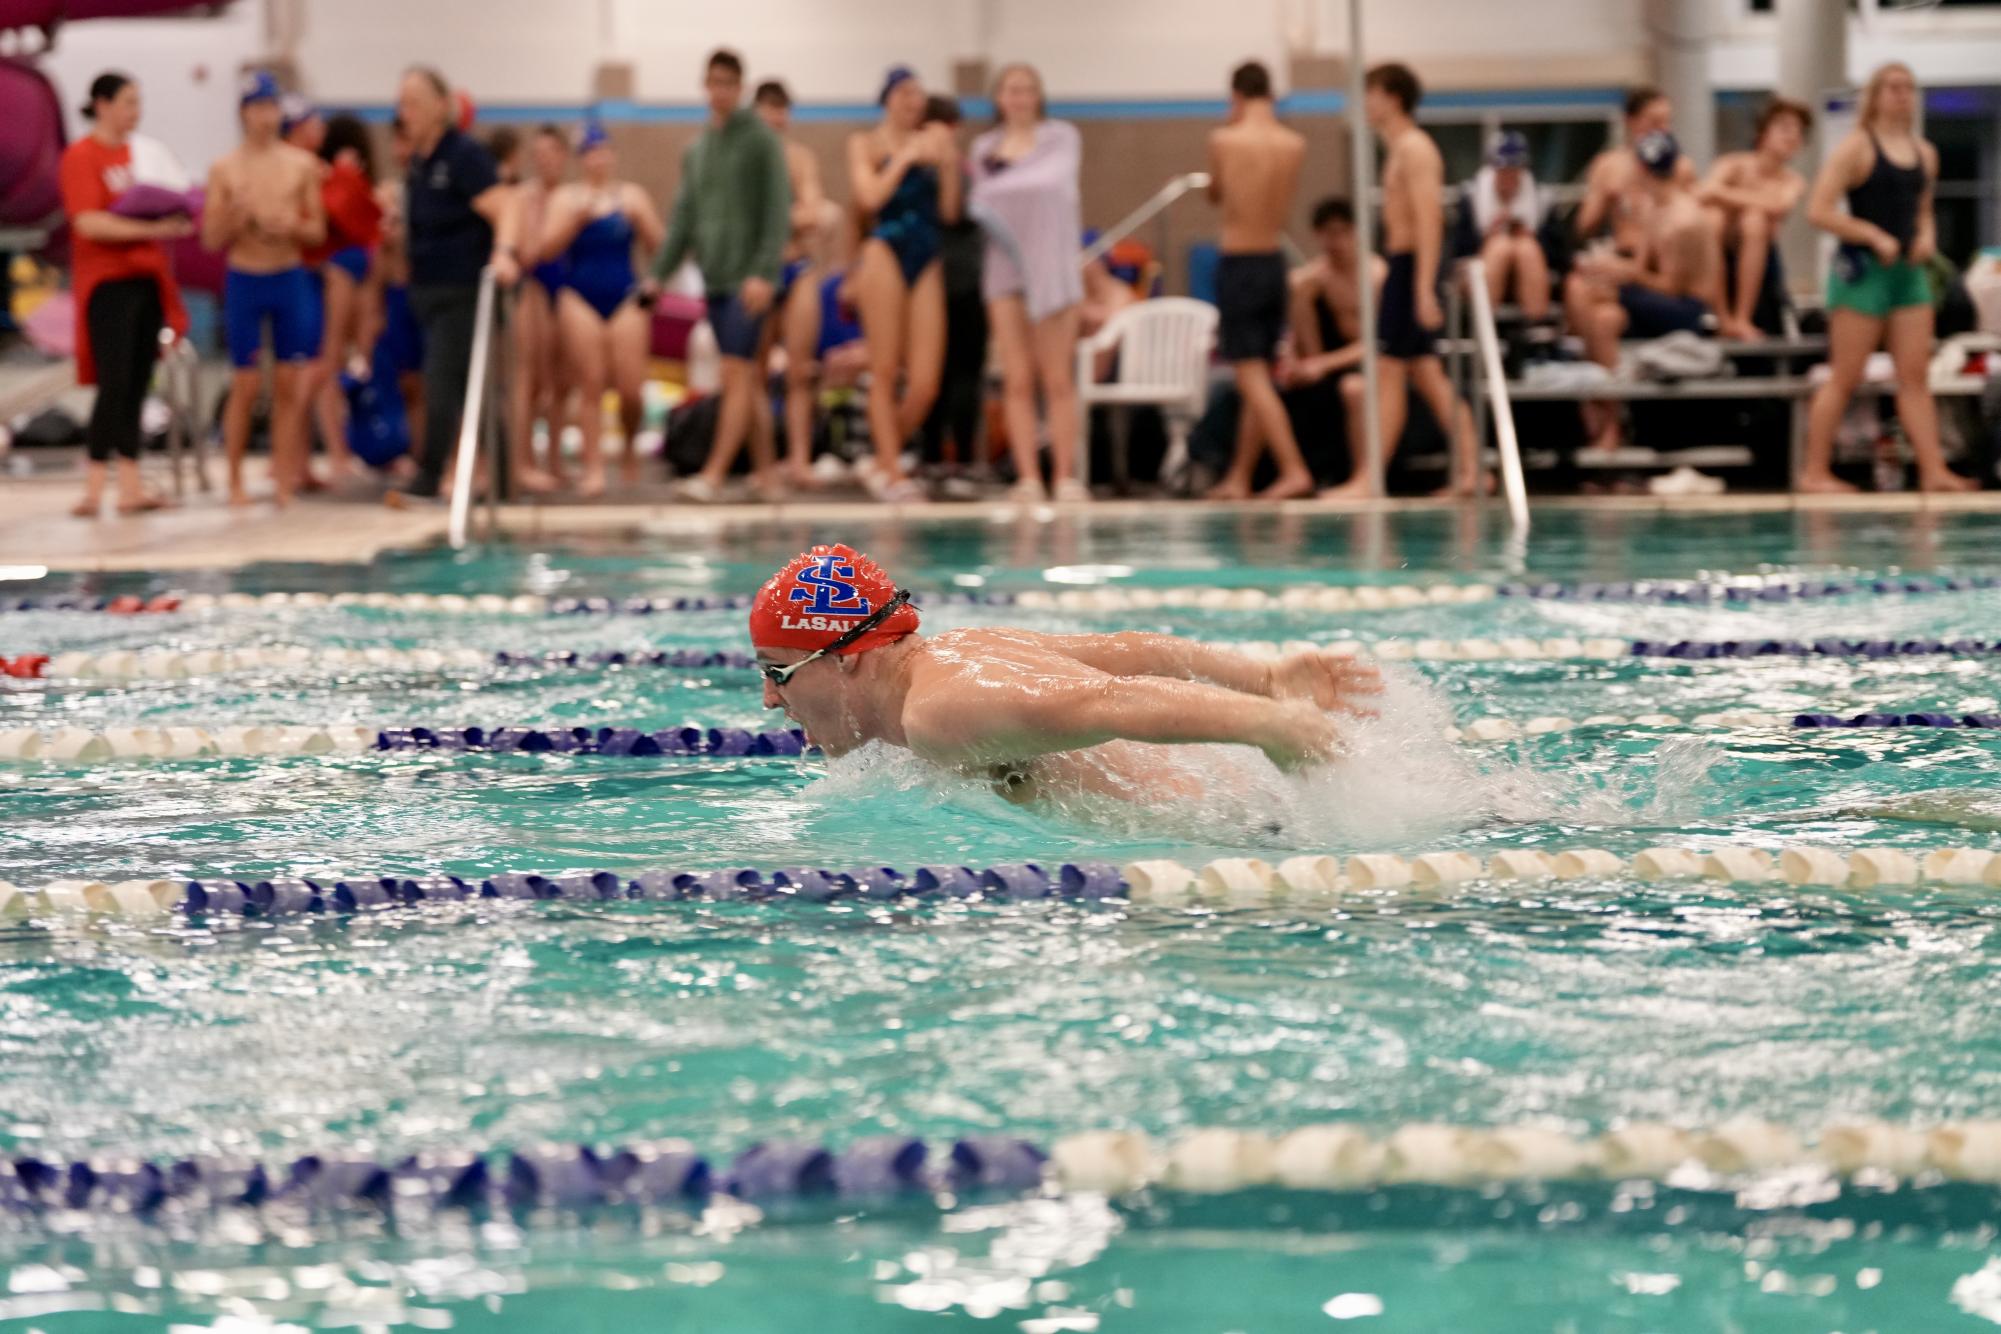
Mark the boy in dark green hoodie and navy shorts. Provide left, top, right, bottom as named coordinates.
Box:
left=640, top=50, right=792, bottom=500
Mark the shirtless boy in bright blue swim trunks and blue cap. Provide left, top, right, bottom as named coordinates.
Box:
left=202, top=74, right=326, bottom=504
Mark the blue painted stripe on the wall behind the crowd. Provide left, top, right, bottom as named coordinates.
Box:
left=350, top=88, right=1623, bottom=124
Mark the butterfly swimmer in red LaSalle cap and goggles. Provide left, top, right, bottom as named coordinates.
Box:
left=750, top=546, right=1381, bottom=802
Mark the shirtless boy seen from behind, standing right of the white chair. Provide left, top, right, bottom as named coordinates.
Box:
left=1209, top=60, right=1313, bottom=500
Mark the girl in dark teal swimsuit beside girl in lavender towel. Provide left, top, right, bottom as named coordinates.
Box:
left=848, top=66, right=960, bottom=502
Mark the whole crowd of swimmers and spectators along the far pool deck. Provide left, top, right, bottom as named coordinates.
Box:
left=62, top=50, right=1973, bottom=516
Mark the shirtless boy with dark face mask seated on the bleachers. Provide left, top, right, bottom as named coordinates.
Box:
left=1573, top=130, right=1723, bottom=448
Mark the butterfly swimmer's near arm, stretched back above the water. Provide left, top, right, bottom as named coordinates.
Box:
left=902, top=676, right=1339, bottom=768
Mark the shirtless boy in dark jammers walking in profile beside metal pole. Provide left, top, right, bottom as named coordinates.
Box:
left=1321, top=64, right=1485, bottom=500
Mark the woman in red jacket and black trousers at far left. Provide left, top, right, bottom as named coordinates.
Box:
left=60, top=72, right=194, bottom=518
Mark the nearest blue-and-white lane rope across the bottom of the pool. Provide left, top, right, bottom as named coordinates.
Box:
left=11, top=1118, right=2001, bottom=1220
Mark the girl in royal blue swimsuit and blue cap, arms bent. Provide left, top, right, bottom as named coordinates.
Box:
left=536, top=124, right=666, bottom=498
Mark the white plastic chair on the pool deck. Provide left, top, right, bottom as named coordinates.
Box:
left=1077, top=296, right=1217, bottom=484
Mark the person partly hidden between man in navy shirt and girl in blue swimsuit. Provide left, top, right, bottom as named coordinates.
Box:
left=508, top=124, right=570, bottom=492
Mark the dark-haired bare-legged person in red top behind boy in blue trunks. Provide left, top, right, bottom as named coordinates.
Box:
left=306, top=116, right=382, bottom=482
